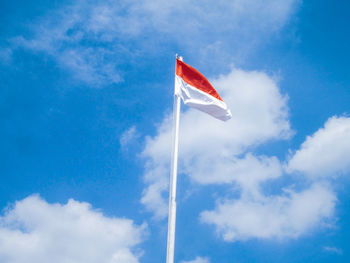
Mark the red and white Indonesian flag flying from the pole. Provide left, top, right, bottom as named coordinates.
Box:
left=175, top=59, right=232, bottom=121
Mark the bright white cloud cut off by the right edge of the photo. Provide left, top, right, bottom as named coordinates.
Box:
left=287, top=117, right=350, bottom=179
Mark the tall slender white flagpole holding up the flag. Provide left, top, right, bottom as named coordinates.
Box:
left=166, top=54, right=182, bottom=263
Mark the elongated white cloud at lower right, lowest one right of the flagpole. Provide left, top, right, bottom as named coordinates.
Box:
left=201, top=184, right=336, bottom=241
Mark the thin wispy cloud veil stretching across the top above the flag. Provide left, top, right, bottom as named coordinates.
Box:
left=6, top=0, right=299, bottom=87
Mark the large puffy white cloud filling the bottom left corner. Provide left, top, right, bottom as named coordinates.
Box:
left=0, top=196, right=146, bottom=263
